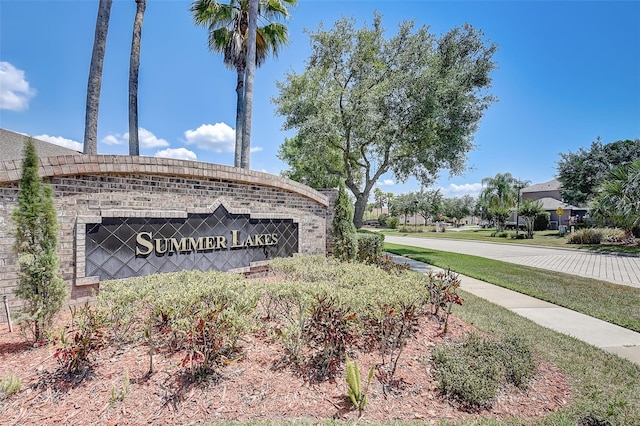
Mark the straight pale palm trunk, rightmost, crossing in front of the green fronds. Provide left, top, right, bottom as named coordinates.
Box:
left=240, top=0, right=259, bottom=169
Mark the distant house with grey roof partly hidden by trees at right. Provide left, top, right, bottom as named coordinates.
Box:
left=520, top=179, right=588, bottom=229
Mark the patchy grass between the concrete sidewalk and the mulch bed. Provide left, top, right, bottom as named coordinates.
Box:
left=454, top=291, right=640, bottom=426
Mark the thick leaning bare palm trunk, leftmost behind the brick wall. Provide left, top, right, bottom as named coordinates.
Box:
left=83, top=0, right=113, bottom=154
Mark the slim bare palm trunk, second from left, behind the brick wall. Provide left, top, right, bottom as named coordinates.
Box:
left=129, top=0, right=147, bottom=155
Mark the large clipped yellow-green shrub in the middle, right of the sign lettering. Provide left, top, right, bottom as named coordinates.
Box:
left=264, top=256, right=429, bottom=380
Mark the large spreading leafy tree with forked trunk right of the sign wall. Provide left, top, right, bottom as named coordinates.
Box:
left=274, top=14, right=496, bottom=227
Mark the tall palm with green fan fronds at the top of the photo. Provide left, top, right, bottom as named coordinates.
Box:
left=191, top=0, right=297, bottom=168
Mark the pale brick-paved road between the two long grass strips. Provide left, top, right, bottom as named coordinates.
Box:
left=384, top=235, right=640, bottom=288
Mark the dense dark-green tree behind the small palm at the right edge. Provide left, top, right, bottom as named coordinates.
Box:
left=557, top=138, right=640, bottom=206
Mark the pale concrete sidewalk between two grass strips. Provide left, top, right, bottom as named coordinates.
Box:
left=384, top=255, right=640, bottom=365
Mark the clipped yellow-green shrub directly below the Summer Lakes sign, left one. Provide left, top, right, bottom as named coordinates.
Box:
left=96, top=271, right=261, bottom=378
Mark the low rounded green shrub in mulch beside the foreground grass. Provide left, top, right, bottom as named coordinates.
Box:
left=432, top=334, right=536, bottom=408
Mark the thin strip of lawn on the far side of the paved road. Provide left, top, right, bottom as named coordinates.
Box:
left=381, top=227, right=640, bottom=254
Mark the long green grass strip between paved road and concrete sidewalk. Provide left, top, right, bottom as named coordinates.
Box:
left=384, top=243, right=640, bottom=332
